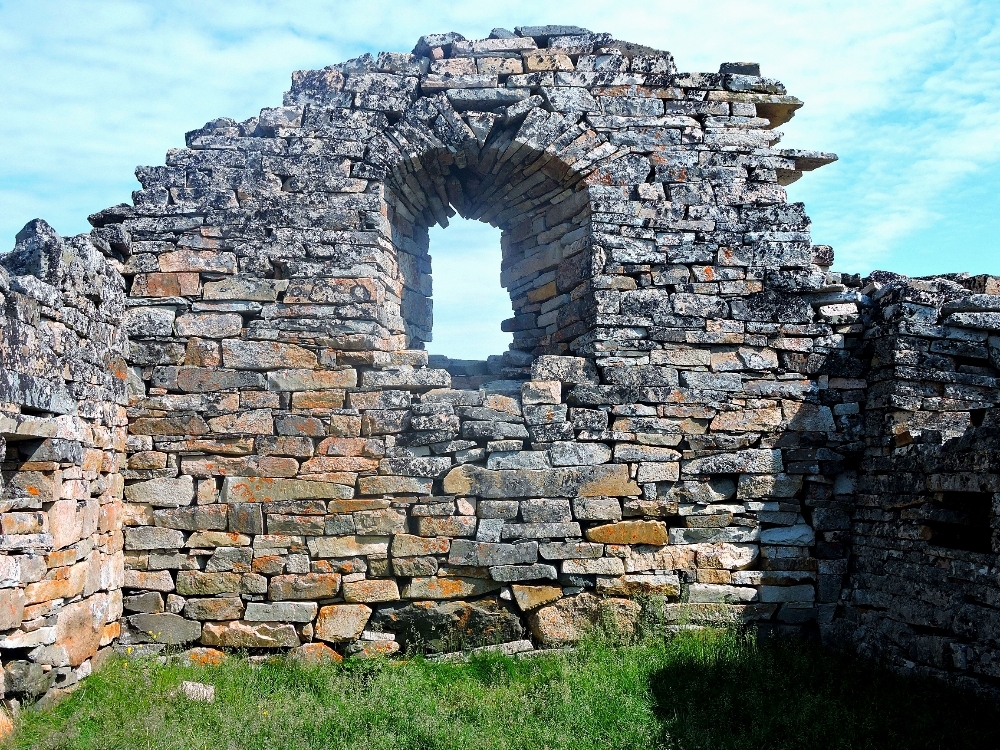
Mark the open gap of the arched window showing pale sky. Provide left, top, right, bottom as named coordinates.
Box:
left=427, top=216, right=513, bottom=360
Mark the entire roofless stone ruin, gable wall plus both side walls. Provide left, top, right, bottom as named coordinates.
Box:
left=0, top=26, right=1000, bottom=696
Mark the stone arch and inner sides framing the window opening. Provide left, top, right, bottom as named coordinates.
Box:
left=376, top=95, right=607, bottom=353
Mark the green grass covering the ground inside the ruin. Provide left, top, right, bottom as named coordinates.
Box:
left=7, top=630, right=1000, bottom=750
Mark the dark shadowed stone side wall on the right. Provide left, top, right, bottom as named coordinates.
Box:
left=824, top=272, right=1000, bottom=690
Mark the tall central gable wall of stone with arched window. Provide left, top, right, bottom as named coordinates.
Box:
left=92, top=28, right=851, bottom=652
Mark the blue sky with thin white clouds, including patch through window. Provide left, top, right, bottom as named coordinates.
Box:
left=0, top=0, right=1000, bottom=356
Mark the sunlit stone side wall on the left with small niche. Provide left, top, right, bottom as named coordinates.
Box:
left=0, top=220, right=127, bottom=701
